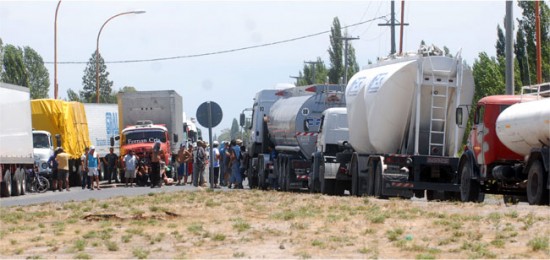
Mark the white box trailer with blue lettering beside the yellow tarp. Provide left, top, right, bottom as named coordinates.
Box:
left=84, top=103, right=120, bottom=157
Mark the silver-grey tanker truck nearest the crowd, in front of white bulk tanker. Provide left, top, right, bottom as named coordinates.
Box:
left=241, top=84, right=345, bottom=191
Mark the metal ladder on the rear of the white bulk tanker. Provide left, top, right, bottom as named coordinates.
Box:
left=428, top=59, right=462, bottom=156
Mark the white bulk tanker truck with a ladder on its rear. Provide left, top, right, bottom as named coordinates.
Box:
left=337, top=47, right=474, bottom=200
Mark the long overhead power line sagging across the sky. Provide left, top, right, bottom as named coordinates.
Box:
left=44, top=15, right=388, bottom=64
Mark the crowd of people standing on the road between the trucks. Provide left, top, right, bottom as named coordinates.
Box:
left=58, top=139, right=252, bottom=191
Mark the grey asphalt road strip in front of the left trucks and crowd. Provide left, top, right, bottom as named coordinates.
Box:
left=0, top=182, right=229, bottom=207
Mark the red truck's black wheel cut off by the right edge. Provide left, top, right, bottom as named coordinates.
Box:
left=527, top=160, right=548, bottom=205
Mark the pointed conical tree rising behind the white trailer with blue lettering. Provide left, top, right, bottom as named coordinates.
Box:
left=80, top=51, right=116, bottom=103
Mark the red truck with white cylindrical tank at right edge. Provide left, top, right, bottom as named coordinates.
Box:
left=457, top=83, right=550, bottom=205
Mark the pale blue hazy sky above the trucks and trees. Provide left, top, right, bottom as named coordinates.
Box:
left=0, top=0, right=536, bottom=138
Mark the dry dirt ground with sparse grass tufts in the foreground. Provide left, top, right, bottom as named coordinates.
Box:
left=0, top=190, right=550, bottom=259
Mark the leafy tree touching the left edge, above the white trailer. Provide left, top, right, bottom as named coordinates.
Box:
left=2, top=44, right=30, bottom=87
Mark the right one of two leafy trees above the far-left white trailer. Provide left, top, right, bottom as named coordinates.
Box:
left=23, top=46, right=50, bottom=99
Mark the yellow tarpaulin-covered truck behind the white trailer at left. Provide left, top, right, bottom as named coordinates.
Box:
left=31, top=99, right=91, bottom=186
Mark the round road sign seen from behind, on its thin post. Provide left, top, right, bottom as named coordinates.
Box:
left=197, top=101, right=223, bottom=189
